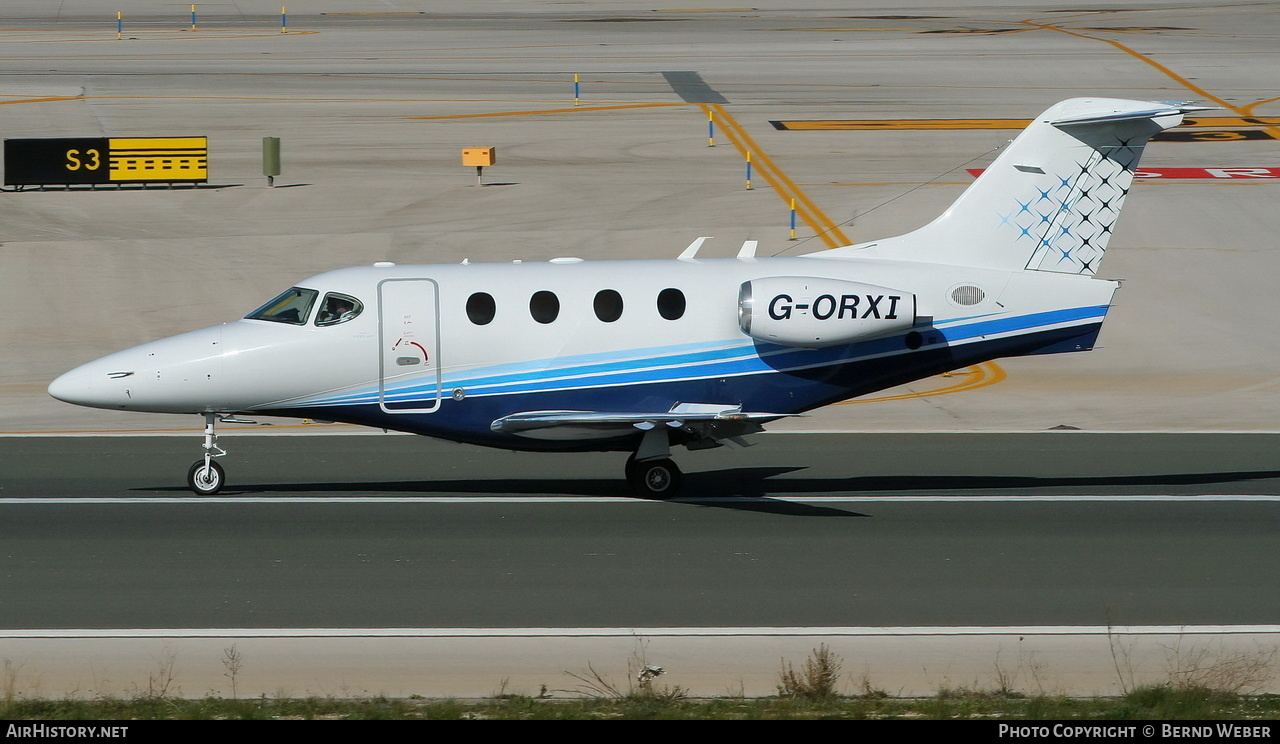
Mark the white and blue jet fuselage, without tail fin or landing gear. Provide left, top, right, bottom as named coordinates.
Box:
left=50, top=251, right=1116, bottom=449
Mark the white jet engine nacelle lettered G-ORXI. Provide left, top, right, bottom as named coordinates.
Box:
left=737, top=277, right=915, bottom=348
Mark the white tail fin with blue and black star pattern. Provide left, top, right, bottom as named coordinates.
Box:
left=849, top=99, right=1199, bottom=275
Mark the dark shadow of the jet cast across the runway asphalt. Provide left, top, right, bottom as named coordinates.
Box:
left=133, top=466, right=1280, bottom=517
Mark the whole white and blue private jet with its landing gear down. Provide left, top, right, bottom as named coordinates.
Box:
left=49, top=97, right=1204, bottom=498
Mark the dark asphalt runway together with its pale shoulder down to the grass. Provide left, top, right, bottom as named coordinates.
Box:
left=0, top=432, right=1280, bottom=695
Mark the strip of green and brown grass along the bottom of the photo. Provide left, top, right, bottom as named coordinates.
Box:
left=0, top=685, right=1280, bottom=721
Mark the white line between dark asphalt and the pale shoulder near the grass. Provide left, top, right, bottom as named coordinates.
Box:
left=0, top=625, right=1280, bottom=640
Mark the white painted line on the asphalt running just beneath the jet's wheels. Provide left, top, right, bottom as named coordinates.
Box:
left=0, top=493, right=1280, bottom=506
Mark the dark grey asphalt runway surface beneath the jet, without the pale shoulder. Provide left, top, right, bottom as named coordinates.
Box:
left=0, top=433, right=1280, bottom=629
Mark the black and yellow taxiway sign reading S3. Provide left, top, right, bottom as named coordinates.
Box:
left=4, top=137, right=209, bottom=186
